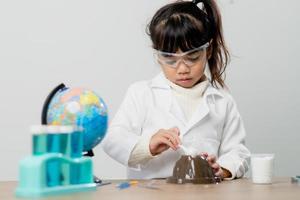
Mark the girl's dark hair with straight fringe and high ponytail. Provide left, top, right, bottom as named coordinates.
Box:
left=147, top=0, right=230, bottom=88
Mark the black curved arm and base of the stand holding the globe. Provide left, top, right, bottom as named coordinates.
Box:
left=41, top=83, right=110, bottom=186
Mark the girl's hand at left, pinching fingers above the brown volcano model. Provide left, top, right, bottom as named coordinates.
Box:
left=149, top=127, right=181, bottom=156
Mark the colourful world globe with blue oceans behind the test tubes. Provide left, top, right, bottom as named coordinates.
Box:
left=47, top=88, right=108, bottom=151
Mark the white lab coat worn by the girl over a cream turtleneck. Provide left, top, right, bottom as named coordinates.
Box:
left=103, top=73, right=250, bottom=179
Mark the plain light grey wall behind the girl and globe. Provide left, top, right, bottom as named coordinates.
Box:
left=0, top=0, right=300, bottom=181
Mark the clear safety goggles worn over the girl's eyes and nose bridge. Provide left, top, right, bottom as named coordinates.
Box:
left=154, top=42, right=209, bottom=69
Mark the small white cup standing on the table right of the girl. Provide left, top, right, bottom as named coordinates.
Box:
left=251, top=154, right=275, bottom=184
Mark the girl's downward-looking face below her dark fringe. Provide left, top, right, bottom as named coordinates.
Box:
left=158, top=50, right=207, bottom=88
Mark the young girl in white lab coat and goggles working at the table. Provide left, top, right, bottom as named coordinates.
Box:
left=103, top=0, right=250, bottom=179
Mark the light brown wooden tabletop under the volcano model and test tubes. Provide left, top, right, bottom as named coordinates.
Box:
left=0, top=177, right=300, bottom=200
